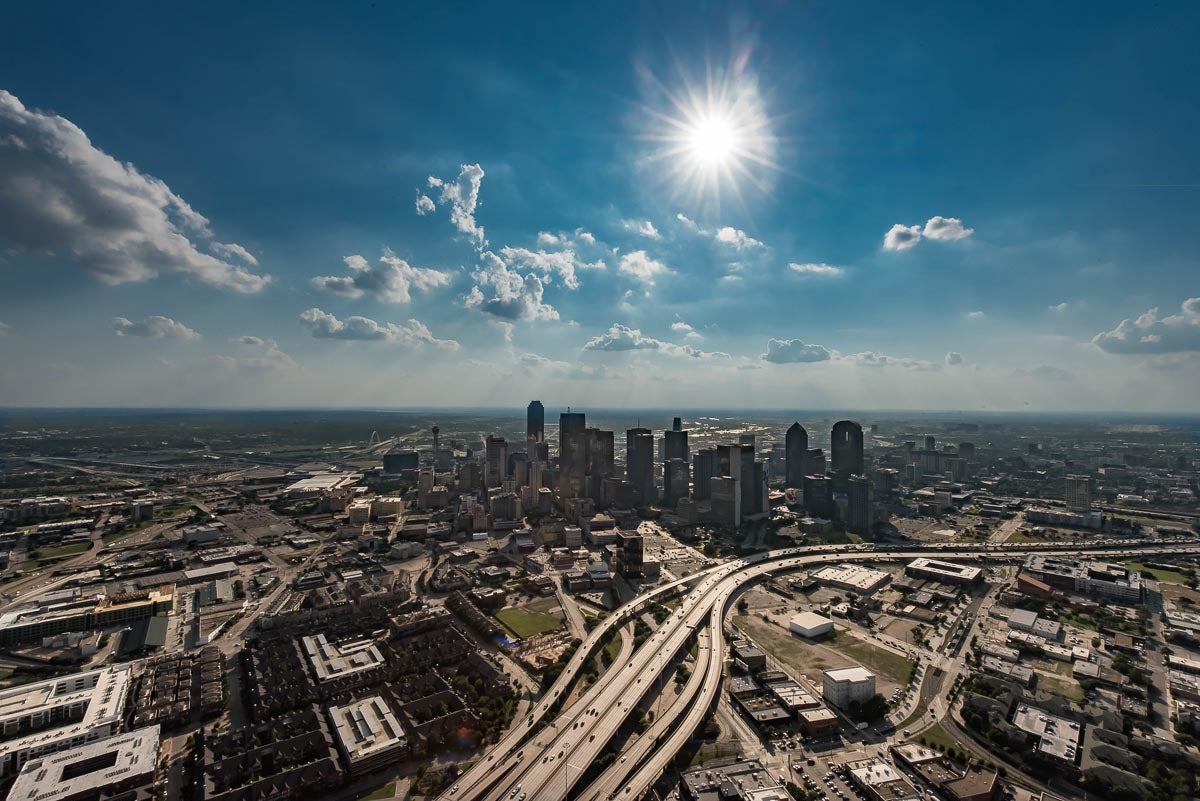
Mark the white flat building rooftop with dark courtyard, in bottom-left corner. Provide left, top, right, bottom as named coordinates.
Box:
left=8, top=725, right=160, bottom=801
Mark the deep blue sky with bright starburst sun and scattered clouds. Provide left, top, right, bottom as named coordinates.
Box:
left=0, top=0, right=1200, bottom=412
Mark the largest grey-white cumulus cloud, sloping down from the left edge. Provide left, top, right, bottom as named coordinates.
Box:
left=0, top=90, right=270, bottom=293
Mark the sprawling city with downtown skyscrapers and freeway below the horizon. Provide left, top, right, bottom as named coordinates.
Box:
left=0, top=401, right=1200, bottom=801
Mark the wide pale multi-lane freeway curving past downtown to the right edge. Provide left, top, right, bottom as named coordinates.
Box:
left=439, top=538, right=1200, bottom=801
